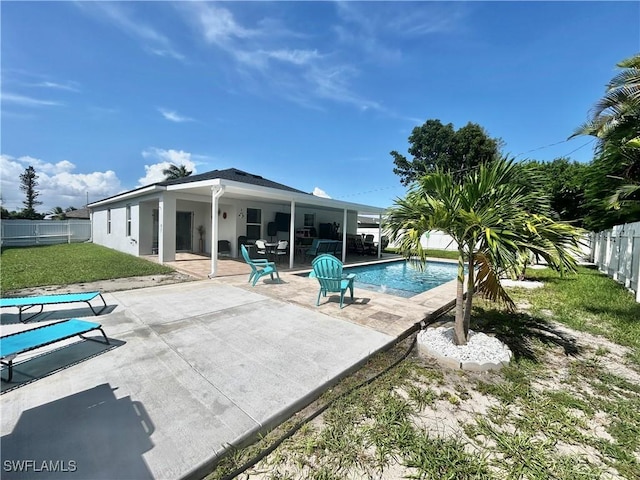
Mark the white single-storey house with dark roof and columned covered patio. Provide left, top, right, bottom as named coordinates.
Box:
left=88, top=168, right=385, bottom=276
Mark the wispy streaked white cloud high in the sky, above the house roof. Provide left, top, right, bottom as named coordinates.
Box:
left=179, top=2, right=382, bottom=110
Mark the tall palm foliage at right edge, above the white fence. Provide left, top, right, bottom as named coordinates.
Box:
left=572, top=54, right=640, bottom=229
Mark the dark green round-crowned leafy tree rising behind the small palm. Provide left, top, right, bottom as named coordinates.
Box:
left=391, top=119, right=502, bottom=185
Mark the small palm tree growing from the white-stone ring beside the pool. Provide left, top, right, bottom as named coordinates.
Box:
left=385, top=159, right=581, bottom=345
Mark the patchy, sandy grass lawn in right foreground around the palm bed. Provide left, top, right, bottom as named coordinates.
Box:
left=208, top=268, right=640, bottom=480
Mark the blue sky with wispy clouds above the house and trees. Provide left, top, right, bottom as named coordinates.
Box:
left=0, top=1, right=640, bottom=212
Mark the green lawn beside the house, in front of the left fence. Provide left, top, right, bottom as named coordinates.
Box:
left=0, top=243, right=174, bottom=293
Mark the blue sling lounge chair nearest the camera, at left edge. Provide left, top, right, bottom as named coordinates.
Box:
left=0, top=318, right=109, bottom=382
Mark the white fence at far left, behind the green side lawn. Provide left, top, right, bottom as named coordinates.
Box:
left=1, top=219, right=91, bottom=247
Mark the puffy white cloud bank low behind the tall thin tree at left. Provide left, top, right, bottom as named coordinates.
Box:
left=0, top=154, right=122, bottom=213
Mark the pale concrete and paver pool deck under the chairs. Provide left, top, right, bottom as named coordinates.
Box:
left=0, top=253, right=455, bottom=479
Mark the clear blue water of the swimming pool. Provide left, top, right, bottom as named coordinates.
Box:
left=344, top=261, right=458, bottom=298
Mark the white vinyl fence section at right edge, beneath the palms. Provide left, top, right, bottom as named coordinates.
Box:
left=591, top=222, right=640, bottom=302
